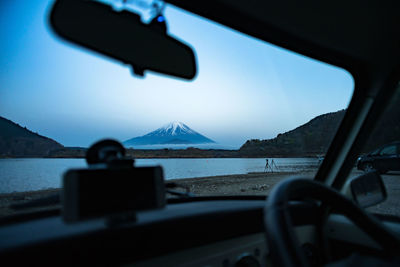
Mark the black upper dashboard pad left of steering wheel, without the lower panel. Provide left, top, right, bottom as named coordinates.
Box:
left=0, top=200, right=265, bottom=265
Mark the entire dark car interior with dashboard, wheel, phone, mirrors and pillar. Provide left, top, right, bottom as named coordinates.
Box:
left=0, top=0, right=400, bottom=267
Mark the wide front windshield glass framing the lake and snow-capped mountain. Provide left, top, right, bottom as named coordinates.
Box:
left=0, top=1, right=353, bottom=218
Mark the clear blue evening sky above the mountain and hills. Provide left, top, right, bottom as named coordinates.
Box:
left=0, top=0, right=353, bottom=147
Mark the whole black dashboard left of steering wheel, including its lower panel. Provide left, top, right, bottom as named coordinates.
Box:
left=0, top=200, right=313, bottom=266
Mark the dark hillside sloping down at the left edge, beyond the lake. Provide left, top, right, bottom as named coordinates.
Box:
left=0, top=117, right=63, bottom=157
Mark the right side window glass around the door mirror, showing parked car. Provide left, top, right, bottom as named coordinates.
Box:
left=349, top=85, right=400, bottom=216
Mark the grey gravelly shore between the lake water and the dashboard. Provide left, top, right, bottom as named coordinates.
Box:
left=0, top=170, right=400, bottom=218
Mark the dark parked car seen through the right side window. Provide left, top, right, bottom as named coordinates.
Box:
left=357, top=142, right=400, bottom=173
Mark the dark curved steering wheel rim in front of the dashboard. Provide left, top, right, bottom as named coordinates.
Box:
left=264, top=178, right=400, bottom=267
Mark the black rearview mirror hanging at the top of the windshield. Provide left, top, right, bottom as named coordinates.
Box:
left=50, top=0, right=196, bottom=79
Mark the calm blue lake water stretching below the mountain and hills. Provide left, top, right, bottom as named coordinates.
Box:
left=0, top=158, right=318, bottom=193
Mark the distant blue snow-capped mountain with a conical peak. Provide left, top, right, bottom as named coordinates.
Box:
left=123, top=122, right=215, bottom=147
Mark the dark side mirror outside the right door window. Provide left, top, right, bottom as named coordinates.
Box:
left=346, top=171, right=387, bottom=208
